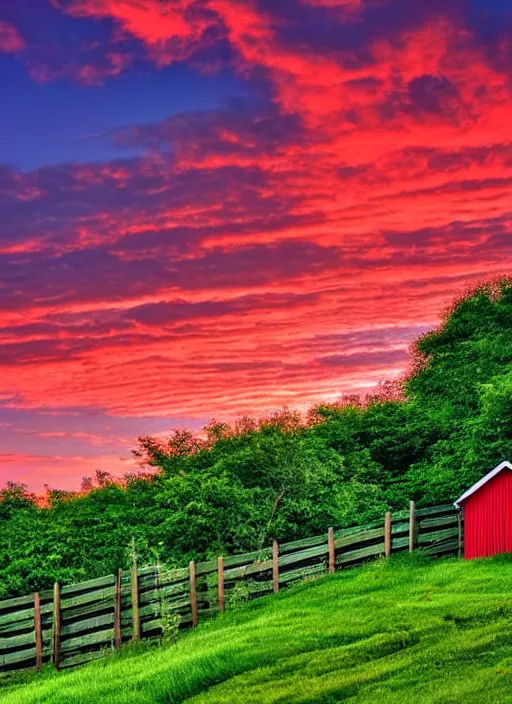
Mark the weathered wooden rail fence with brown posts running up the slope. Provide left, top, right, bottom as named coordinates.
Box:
left=0, top=502, right=461, bottom=673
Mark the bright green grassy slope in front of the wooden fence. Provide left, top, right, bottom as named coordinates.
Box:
left=0, top=556, right=512, bottom=704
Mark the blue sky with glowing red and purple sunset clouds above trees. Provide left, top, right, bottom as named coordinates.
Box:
left=0, top=0, right=512, bottom=491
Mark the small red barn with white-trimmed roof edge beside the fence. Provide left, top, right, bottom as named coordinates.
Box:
left=455, top=462, right=512, bottom=560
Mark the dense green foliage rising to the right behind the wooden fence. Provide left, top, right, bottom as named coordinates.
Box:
left=0, top=280, right=512, bottom=598
